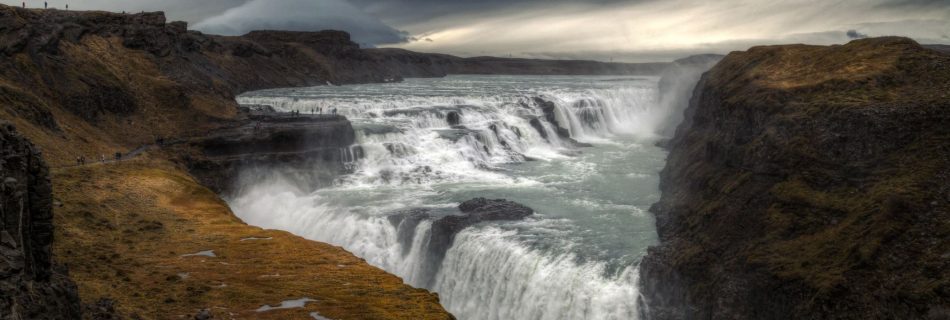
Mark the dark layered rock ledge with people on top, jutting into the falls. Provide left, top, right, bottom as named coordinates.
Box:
left=176, top=113, right=361, bottom=194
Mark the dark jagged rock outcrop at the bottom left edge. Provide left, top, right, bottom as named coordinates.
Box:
left=0, top=121, right=81, bottom=320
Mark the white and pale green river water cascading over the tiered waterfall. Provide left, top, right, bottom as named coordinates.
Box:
left=229, top=76, right=669, bottom=319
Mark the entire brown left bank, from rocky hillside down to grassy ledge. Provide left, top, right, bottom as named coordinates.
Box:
left=0, top=5, right=460, bottom=319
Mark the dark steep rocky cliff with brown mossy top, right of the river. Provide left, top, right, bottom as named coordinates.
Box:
left=641, top=38, right=950, bottom=319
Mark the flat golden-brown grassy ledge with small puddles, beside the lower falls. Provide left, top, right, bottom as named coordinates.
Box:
left=53, top=159, right=448, bottom=319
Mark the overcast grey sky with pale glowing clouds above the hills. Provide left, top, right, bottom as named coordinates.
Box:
left=9, top=0, right=950, bottom=61
